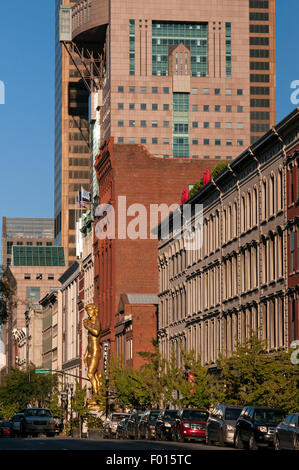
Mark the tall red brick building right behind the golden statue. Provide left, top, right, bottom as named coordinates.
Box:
left=94, top=137, right=217, bottom=368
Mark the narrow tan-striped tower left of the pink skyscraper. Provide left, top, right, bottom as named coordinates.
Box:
left=54, top=0, right=90, bottom=265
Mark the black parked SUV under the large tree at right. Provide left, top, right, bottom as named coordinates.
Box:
left=235, top=406, right=284, bottom=450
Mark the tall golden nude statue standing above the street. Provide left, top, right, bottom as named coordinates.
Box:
left=83, top=304, right=102, bottom=395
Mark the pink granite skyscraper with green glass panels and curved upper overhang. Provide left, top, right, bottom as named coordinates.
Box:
left=60, top=0, right=275, bottom=159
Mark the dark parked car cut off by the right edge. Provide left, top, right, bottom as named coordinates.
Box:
left=274, top=413, right=299, bottom=450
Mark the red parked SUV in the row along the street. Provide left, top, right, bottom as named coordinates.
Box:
left=172, top=408, right=209, bottom=442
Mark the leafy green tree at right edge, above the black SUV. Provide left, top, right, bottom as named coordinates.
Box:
left=214, top=334, right=298, bottom=413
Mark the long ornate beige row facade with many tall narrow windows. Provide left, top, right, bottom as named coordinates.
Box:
left=158, top=109, right=299, bottom=364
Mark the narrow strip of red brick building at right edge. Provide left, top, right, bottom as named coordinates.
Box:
left=286, top=147, right=299, bottom=343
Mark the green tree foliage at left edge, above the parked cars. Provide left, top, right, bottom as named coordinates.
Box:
left=0, top=365, right=58, bottom=415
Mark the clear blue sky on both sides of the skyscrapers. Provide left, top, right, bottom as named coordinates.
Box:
left=0, top=0, right=299, bottom=253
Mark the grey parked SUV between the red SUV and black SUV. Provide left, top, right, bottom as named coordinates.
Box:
left=206, top=404, right=243, bottom=446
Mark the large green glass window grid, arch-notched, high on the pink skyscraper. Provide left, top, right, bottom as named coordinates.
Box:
left=152, top=21, right=208, bottom=77
